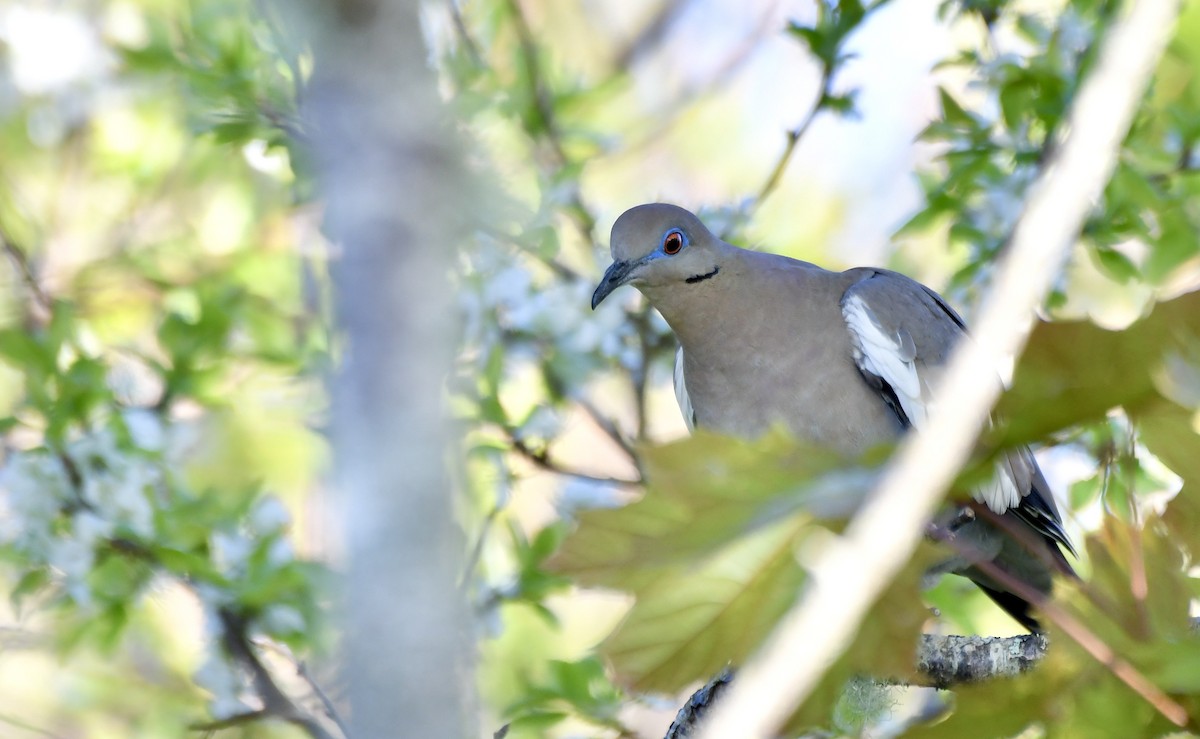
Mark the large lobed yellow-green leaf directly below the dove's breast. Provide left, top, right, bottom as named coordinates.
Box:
left=551, top=432, right=928, bottom=700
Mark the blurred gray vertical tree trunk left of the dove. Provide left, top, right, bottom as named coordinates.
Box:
left=306, top=0, right=474, bottom=739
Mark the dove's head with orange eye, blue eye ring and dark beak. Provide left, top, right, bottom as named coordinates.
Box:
left=592, top=203, right=725, bottom=308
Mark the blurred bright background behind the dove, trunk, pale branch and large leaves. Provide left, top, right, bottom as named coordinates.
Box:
left=0, top=0, right=1200, bottom=737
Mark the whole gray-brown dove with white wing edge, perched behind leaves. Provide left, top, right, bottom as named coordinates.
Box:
left=592, top=203, right=1074, bottom=630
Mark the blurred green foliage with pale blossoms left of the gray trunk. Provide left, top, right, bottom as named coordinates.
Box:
left=0, top=0, right=334, bottom=737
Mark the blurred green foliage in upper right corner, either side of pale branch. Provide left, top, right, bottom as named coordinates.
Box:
left=905, top=0, right=1200, bottom=306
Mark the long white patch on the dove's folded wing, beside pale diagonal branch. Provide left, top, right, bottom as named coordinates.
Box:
left=841, top=294, right=926, bottom=427
